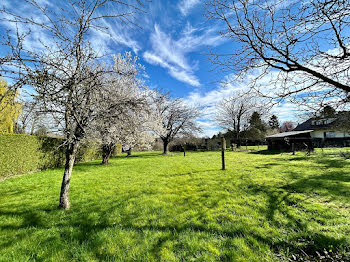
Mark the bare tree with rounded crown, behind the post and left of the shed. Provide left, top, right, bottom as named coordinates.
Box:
left=215, top=93, right=258, bottom=147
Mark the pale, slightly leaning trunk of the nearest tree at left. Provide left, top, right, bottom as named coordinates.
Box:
left=59, top=141, right=79, bottom=209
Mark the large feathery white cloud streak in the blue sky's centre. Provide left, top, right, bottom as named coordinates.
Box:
left=143, top=24, right=222, bottom=86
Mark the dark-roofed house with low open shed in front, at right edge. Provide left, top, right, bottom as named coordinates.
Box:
left=266, top=112, right=350, bottom=151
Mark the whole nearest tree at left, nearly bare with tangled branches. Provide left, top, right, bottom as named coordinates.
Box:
left=1, top=0, right=144, bottom=209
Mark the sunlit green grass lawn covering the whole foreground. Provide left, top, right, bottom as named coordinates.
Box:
left=0, top=149, right=350, bottom=261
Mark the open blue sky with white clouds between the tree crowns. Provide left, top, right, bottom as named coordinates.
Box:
left=0, top=0, right=304, bottom=136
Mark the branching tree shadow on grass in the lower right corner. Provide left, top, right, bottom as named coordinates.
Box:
left=239, top=176, right=350, bottom=261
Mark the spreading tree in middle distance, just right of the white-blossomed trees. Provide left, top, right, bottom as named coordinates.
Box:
left=154, top=93, right=201, bottom=155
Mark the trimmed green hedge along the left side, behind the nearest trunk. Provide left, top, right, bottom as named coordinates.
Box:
left=0, top=134, right=101, bottom=178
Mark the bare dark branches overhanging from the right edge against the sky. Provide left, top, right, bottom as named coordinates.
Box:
left=207, top=0, right=350, bottom=106
